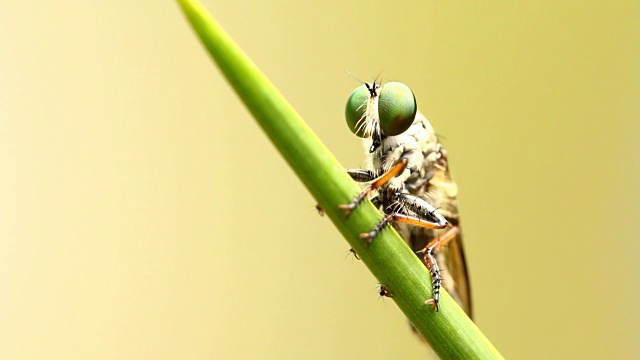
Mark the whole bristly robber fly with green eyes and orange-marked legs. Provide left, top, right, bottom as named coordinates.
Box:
left=340, top=82, right=471, bottom=316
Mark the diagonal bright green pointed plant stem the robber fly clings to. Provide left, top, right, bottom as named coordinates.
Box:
left=178, top=0, right=502, bottom=359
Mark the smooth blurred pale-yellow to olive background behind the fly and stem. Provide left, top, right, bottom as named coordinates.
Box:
left=0, top=0, right=640, bottom=359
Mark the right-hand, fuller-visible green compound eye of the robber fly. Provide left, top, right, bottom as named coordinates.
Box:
left=378, top=82, right=418, bottom=136
